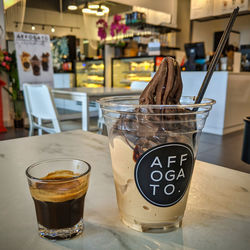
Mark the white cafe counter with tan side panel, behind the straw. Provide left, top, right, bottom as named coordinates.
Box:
left=181, top=71, right=250, bottom=135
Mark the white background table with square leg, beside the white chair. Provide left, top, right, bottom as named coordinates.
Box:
left=51, top=87, right=142, bottom=131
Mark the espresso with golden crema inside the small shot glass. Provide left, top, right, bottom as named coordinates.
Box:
left=30, top=170, right=88, bottom=229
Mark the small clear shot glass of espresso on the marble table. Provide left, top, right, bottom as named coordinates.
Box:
left=26, top=159, right=91, bottom=240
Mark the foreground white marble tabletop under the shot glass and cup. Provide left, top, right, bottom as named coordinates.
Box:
left=0, top=130, right=250, bottom=250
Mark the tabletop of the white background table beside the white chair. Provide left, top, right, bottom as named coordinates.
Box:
left=52, top=87, right=142, bottom=96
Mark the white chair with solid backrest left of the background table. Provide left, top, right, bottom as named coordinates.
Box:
left=23, top=83, right=81, bottom=136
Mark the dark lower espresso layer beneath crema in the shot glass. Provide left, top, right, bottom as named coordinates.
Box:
left=33, top=194, right=85, bottom=229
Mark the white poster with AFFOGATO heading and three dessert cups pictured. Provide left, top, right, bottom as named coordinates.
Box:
left=14, top=32, right=53, bottom=89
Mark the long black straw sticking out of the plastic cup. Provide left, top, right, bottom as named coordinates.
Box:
left=194, top=7, right=239, bottom=105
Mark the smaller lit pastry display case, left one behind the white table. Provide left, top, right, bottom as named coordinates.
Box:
left=76, top=59, right=105, bottom=88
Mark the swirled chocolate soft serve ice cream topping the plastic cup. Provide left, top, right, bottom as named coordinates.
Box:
left=112, top=57, right=196, bottom=159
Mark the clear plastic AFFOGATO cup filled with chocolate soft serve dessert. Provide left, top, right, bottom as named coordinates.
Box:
left=100, top=57, right=211, bottom=231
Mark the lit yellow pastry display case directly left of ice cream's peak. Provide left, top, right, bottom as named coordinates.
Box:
left=112, top=56, right=164, bottom=88
